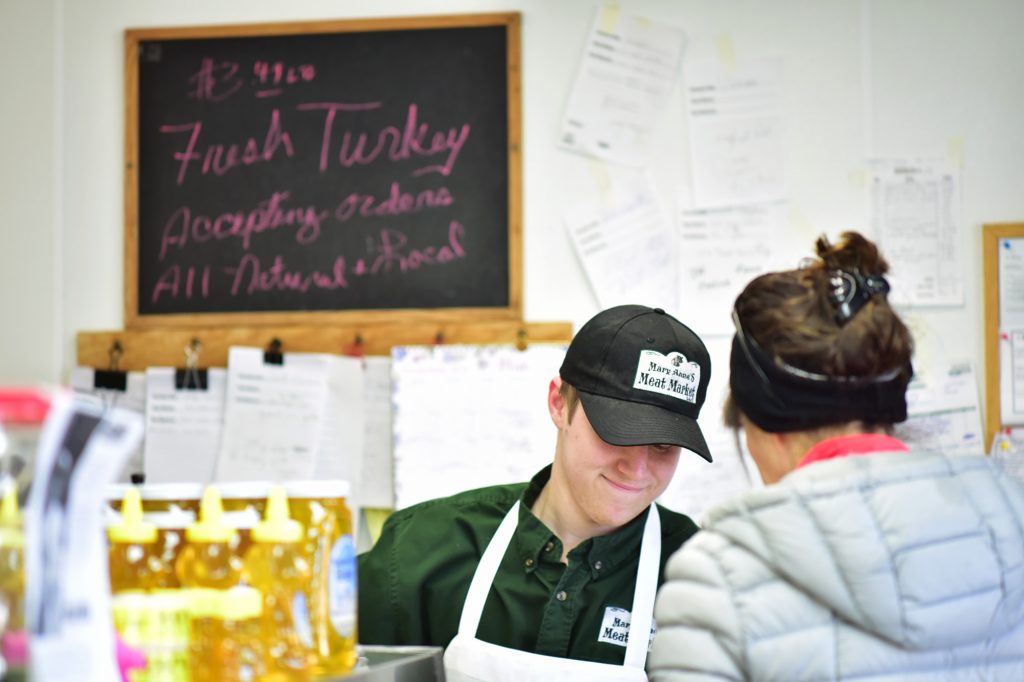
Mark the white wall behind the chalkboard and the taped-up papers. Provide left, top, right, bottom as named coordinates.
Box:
left=0, top=0, right=1024, bottom=425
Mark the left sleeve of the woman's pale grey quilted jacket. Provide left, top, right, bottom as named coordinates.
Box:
left=647, top=531, right=744, bottom=682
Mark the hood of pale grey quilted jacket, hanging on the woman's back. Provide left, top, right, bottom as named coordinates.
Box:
left=706, top=453, right=1024, bottom=649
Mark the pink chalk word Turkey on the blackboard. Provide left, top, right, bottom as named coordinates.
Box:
left=298, top=102, right=470, bottom=176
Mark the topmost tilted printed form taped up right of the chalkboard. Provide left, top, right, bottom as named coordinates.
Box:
left=559, top=6, right=686, bottom=166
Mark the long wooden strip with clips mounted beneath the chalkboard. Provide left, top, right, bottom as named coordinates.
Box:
left=77, top=321, right=572, bottom=371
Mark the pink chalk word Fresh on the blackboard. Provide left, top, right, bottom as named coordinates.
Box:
left=160, top=110, right=295, bottom=184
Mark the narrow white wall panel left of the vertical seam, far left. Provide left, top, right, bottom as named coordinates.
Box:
left=0, top=0, right=61, bottom=386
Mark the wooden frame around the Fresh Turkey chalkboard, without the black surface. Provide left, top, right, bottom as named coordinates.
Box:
left=124, top=12, right=522, bottom=329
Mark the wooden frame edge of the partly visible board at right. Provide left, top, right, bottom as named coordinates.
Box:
left=981, top=222, right=1024, bottom=446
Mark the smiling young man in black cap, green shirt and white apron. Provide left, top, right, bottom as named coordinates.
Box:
left=359, top=305, right=712, bottom=680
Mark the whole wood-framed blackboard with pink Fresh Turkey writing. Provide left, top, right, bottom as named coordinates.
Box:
left=125, top=13, right=521, bottom=327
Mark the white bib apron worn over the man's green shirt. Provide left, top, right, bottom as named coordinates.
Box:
left=444, top=502, right=662, bottom=682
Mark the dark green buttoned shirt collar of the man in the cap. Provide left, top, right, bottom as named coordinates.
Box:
left=515, top=464, right=647, bottom=579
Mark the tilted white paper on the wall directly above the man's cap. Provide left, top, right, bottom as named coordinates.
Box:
left=563, top=169, right=676, bottom=310
